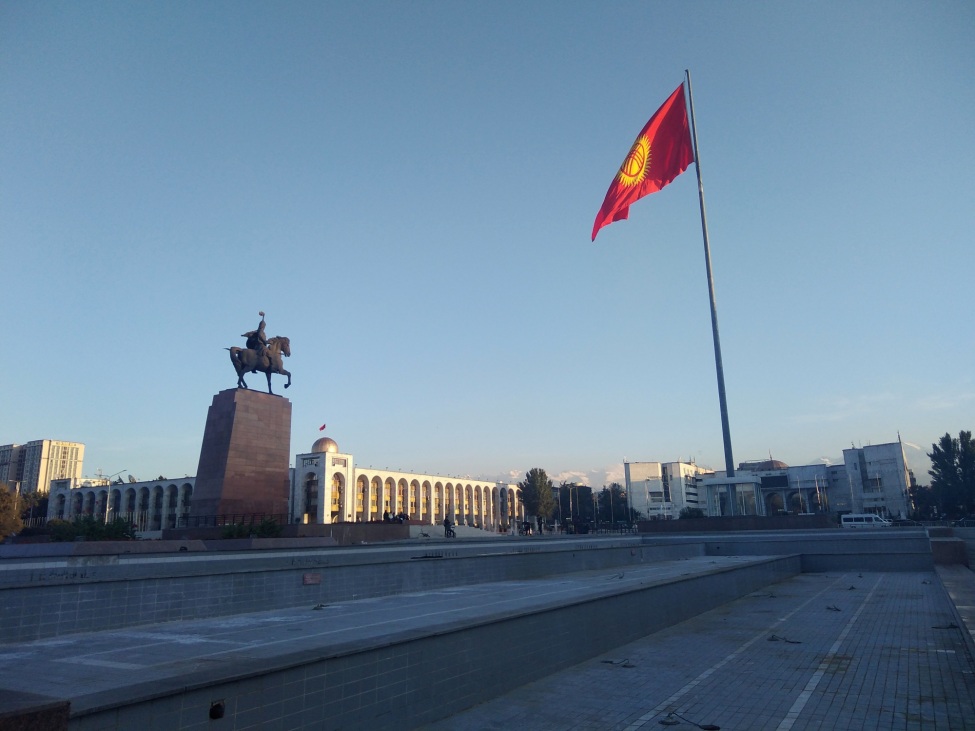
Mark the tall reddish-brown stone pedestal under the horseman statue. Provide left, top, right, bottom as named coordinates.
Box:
left=190, top=388, right=291, bottom=524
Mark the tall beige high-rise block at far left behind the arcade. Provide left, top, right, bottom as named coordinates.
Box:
left=0, top=439, right=85, bottom=495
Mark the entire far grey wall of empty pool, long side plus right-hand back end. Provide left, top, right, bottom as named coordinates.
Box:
left=0, top=532, right=932, bottom=642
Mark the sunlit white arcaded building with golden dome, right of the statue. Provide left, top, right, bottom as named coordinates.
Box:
left=289, top=437, right=525, bottom=531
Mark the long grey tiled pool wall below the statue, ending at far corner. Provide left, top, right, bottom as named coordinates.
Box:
left=0, top=526, right=704, bottom=642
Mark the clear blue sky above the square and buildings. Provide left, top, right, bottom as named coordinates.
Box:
left=0, top=1, right=975, bottom=486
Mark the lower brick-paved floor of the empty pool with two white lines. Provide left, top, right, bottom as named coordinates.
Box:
left=425, top=568, right=975, bottom=731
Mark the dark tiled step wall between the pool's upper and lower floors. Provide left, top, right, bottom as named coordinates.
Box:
left=73, top=556, right=800, bottom=731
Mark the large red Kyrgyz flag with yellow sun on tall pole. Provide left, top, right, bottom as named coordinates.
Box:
left=592, top=84, right=694, bottom=241
